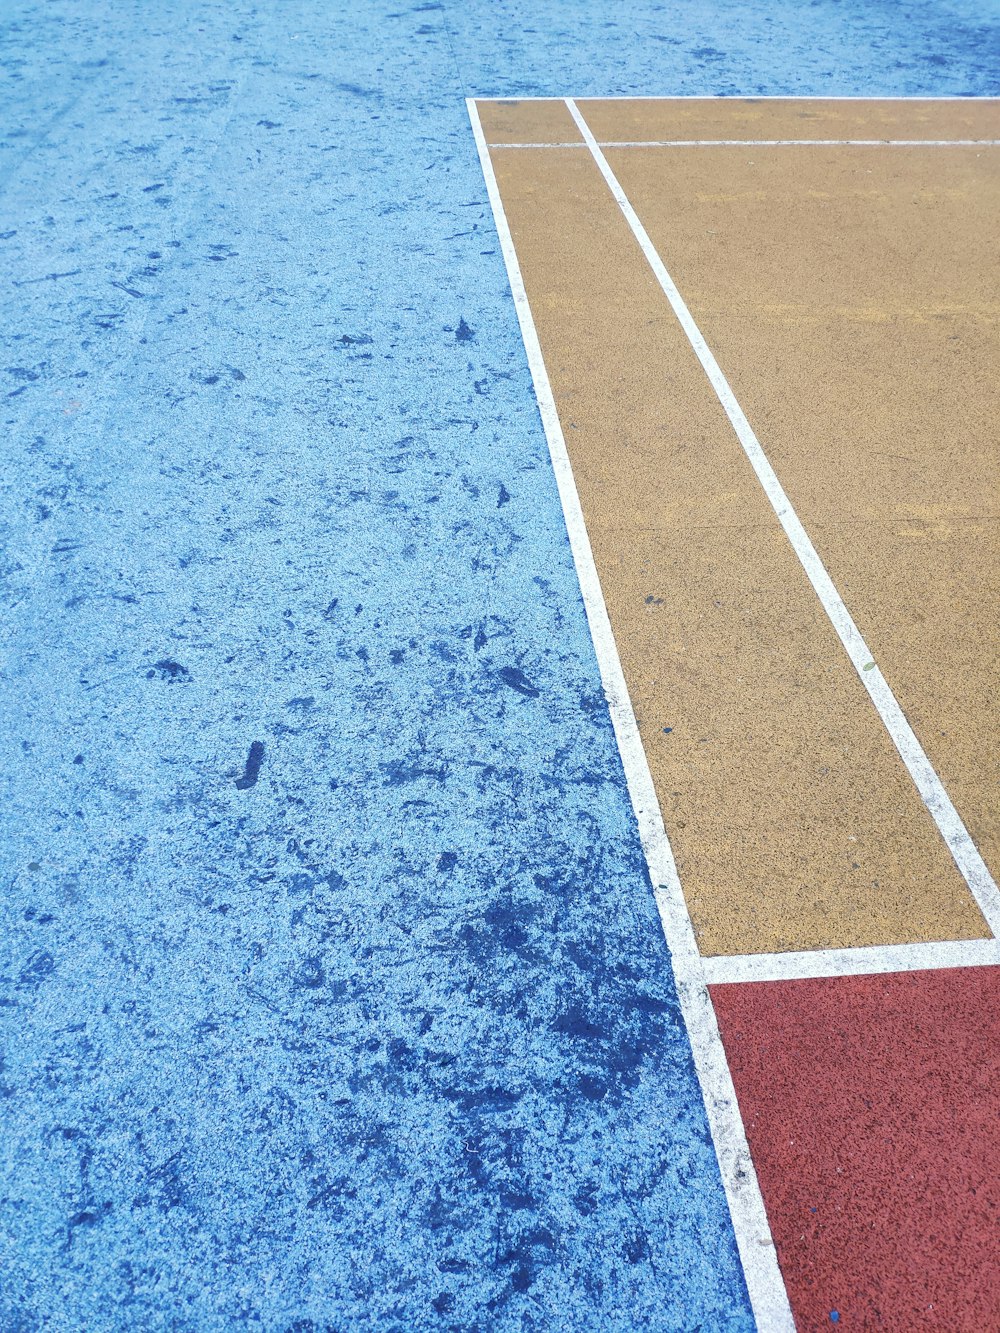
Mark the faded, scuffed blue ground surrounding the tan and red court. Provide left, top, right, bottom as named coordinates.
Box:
left=0, top=0, right=1000, bottom=1333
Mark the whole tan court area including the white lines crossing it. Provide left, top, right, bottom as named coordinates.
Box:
left=477, top=99, right=1000, bottom=954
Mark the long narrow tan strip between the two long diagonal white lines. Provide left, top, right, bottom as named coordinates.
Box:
left=493, top=117, right=988, bottom=954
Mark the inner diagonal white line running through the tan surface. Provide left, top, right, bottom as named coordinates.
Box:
left=567, top=97, right=1000, bottom=936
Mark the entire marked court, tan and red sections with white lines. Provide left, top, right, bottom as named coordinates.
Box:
left=471, top=88, right=1000, bottom=1328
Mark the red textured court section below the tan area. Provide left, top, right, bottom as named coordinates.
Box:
left=712, top=968, right=1000, bottom=1333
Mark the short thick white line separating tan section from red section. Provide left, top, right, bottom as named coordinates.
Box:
left=703, top=940, right=1000, bottom=986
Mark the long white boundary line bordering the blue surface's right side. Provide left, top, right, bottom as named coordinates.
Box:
left=468, top=99, right=795, bottom=1333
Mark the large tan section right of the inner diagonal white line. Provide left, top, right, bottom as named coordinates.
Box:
left=609, top=119, right=1000, bottom=876
